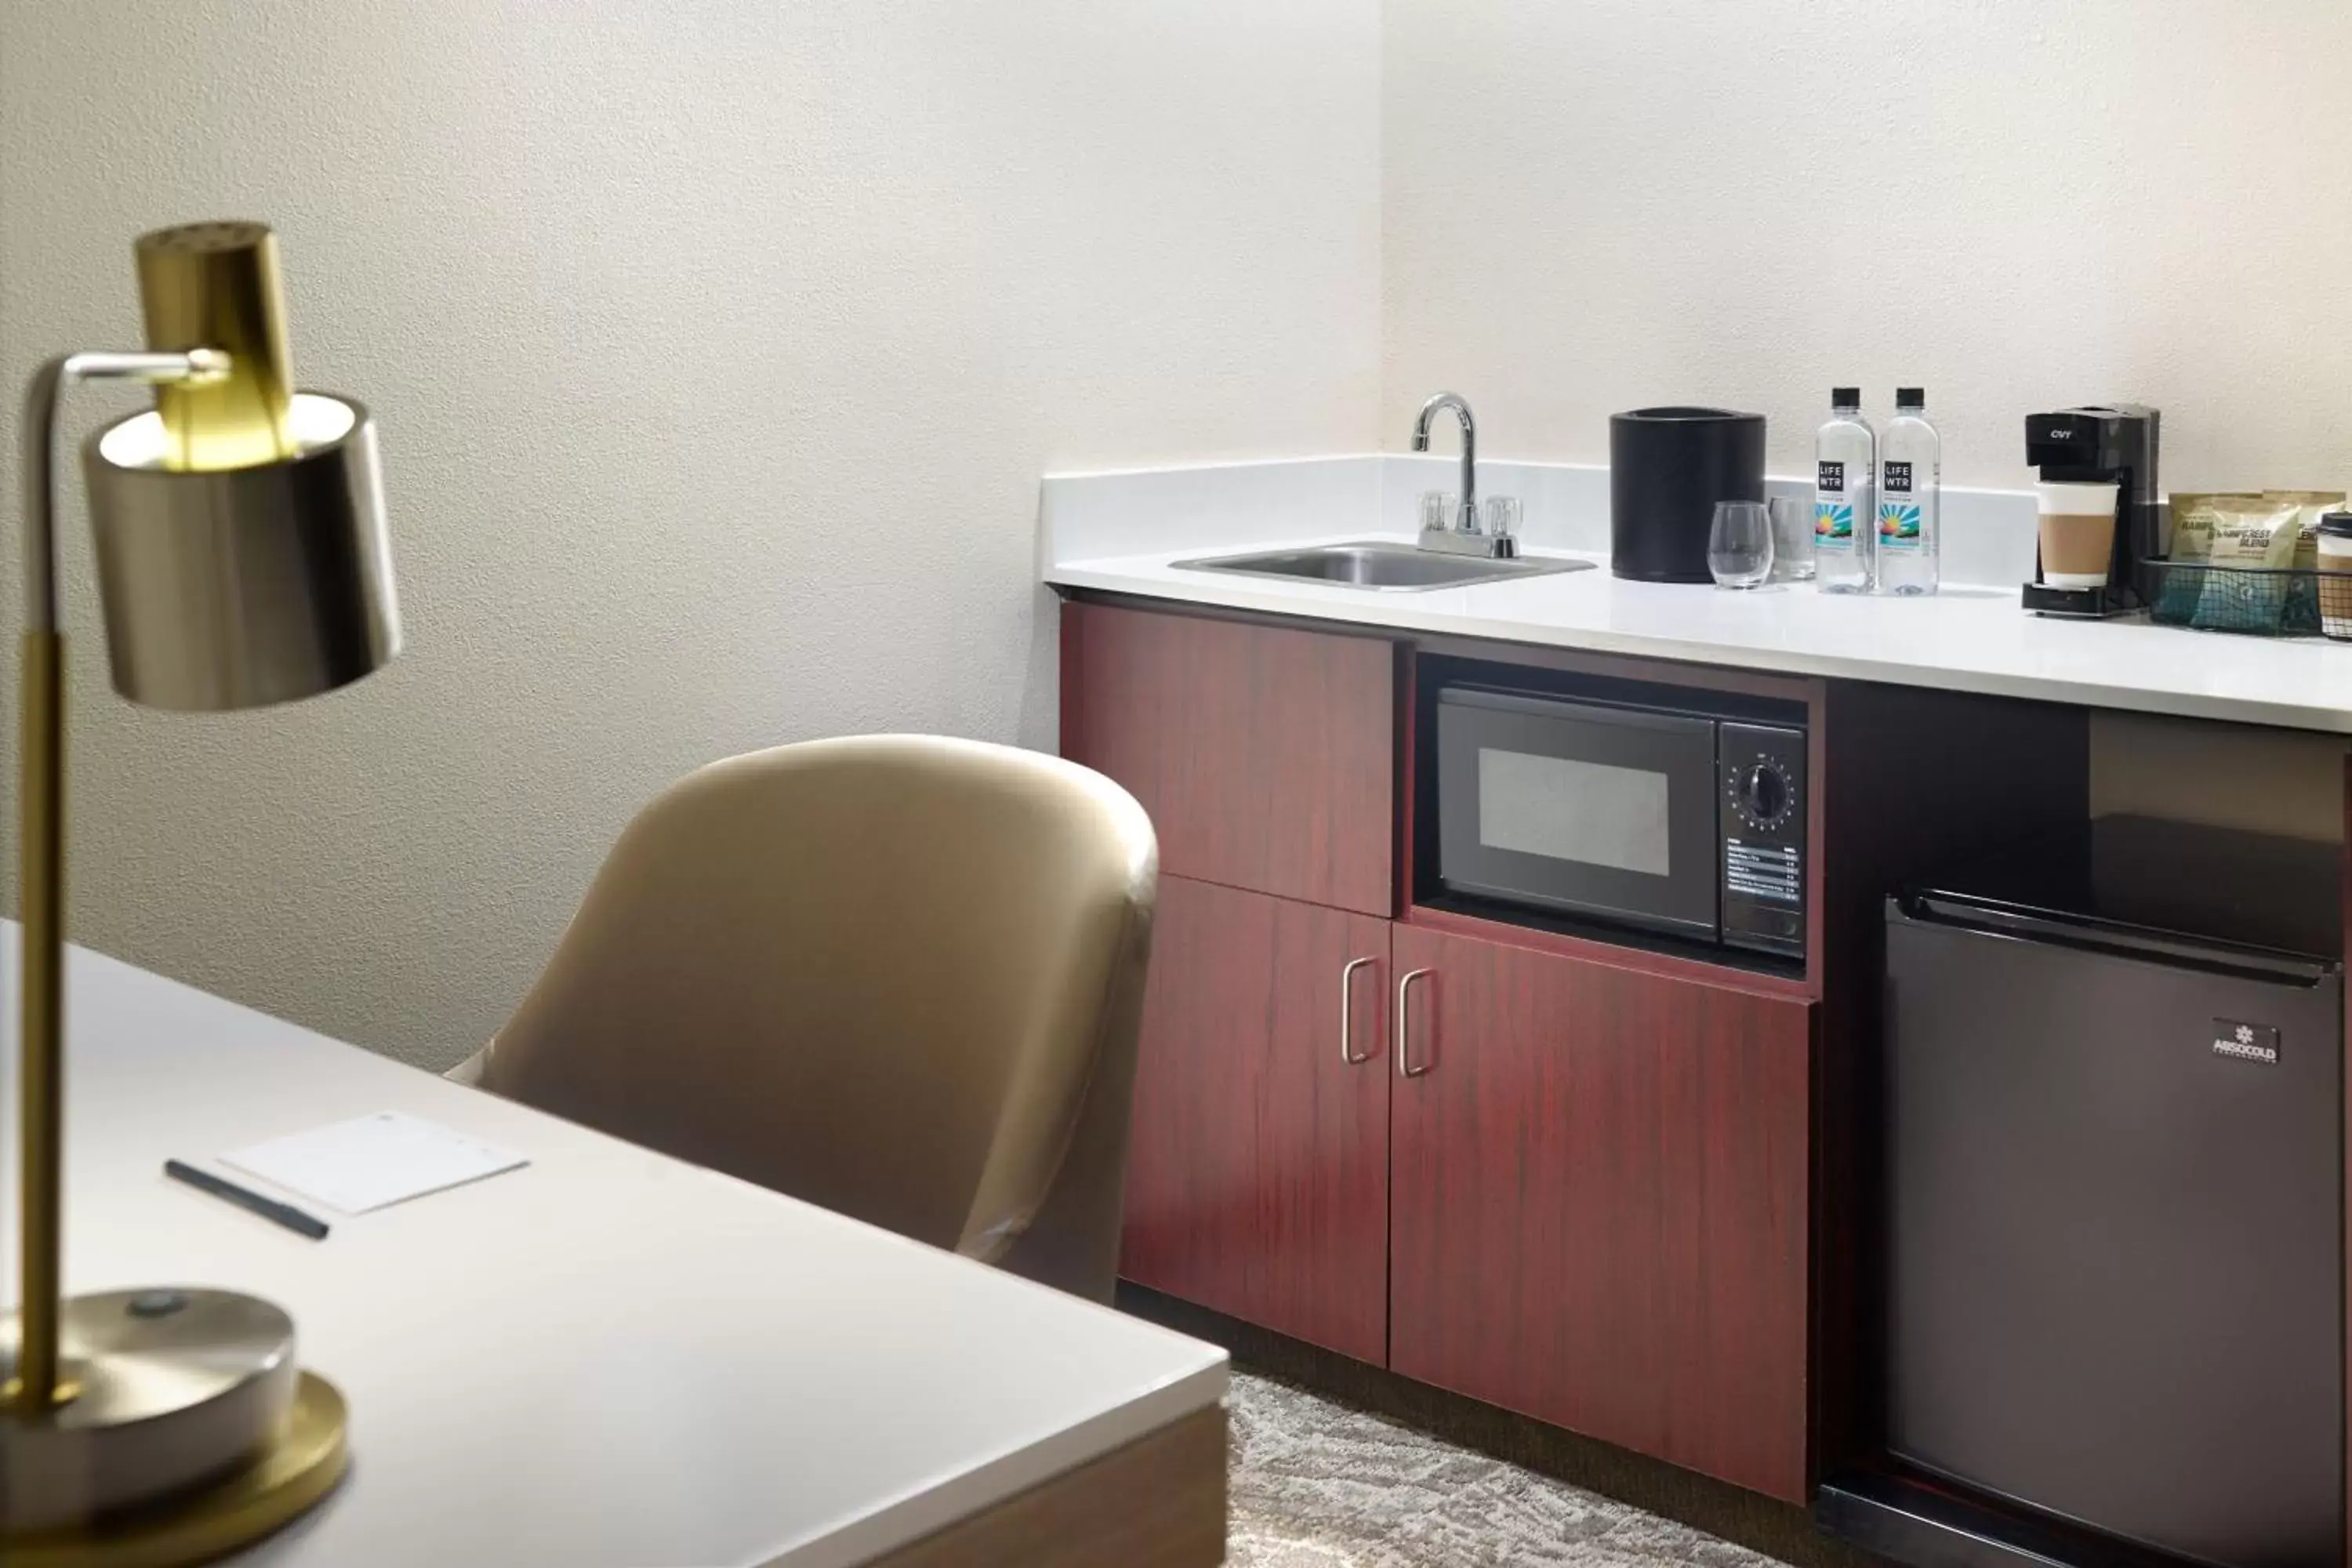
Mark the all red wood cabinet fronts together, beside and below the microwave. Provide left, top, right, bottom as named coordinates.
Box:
left=1061, top=602, right=1813, bottom=1502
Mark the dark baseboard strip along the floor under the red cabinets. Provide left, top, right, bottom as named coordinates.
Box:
left=1117, top=1279, right=1886, bottom=1568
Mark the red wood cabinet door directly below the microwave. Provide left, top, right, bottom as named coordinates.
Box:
left=1390, top=926, right=1811, bottom=1502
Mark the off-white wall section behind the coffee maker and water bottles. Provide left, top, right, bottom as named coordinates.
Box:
left=1381, top=0, right=2352, bottom=489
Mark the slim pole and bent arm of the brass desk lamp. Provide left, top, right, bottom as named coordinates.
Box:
left=5, top=348, right=228, bottom=1417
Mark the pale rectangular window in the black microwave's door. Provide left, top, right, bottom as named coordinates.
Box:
left=1477, top=746, right=1675, bottom=877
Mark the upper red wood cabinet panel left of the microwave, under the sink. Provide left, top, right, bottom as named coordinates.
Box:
left=1061, top=604, right=1397, bottom=914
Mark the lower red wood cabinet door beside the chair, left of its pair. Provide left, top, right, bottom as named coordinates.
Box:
left=1120, top=877, right=1388, bottom=1361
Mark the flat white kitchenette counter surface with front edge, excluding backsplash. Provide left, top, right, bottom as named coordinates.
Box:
left=1044, top=529, right=2352, bottom=734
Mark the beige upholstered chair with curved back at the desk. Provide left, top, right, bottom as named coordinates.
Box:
left=449, top=736, right=1157, bottom=1300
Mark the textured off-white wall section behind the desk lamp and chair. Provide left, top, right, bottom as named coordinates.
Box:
left=0, top=0, right=1381, bottom=1065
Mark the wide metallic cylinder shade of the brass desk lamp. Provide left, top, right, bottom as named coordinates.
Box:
left=82, top=393, right=400, bottom=713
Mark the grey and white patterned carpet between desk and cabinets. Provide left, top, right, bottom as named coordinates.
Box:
left=1228, top=1373, right=1780, bottom=1568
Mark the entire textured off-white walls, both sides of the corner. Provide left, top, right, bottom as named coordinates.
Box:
left=13, top=0, right=2352, bottom=1065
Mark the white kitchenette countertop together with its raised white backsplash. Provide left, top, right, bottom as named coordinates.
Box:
left=1040, top=454, right=2352, bottom=734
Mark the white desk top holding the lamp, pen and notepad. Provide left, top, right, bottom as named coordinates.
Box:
left=0, top=940, right=1225, bottom=1568
